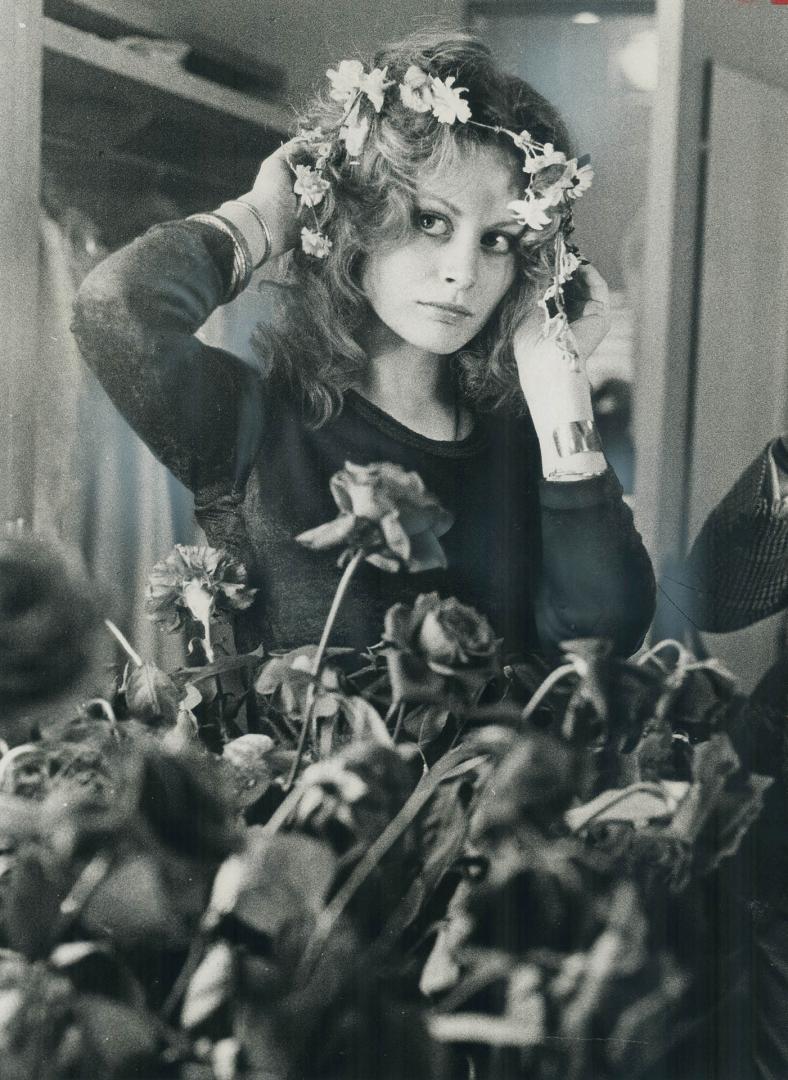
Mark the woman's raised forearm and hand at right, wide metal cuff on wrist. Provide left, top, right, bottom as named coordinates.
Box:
left=515, top=266, right=655, bottom=656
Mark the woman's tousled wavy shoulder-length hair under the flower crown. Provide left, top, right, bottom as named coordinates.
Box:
left=253, top=32, right=571, bottom=427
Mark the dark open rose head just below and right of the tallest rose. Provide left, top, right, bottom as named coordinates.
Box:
left=384, top=593, right=501, bottom=700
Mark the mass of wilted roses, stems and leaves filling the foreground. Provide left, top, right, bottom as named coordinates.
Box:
left=0, top=471, right=771, bottom=1080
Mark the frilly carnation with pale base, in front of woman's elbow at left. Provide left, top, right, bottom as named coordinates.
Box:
left=145, top=543, right=257, bottom=662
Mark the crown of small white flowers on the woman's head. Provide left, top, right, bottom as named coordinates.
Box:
left=289, top=60, right=594, bottom=364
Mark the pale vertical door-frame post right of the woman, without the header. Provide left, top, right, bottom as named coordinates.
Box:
left=635, top=0, right=703, bottom=564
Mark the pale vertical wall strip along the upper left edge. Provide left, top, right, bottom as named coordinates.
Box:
left=0, top=0, right=42, bottom=523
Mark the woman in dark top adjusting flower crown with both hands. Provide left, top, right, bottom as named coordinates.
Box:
left=74, top=36, right=653, bottom=653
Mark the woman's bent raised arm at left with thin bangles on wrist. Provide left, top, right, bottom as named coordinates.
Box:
left=72, top=148, right=296, bottom=490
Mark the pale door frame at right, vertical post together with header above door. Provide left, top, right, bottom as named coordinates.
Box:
left=635, top=0, right=788, bottom=564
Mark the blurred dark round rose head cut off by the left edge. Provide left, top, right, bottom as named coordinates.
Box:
left=0, top=537, right=99, bottom=705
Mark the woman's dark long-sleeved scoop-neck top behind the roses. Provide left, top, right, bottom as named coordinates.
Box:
left=73, top=220, right=654, bottom=653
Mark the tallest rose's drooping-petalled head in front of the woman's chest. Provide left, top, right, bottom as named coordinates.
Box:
left=296, top=461, right=454, bottom=573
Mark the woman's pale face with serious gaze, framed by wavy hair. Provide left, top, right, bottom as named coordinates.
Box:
left=362, top=147, right=521, bottom=355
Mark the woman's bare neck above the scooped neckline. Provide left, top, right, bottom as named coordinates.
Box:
left=355, top=341, right=473, bottom=441
